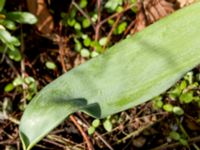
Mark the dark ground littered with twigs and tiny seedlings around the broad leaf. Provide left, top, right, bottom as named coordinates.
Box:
left=0, top=0, right=200, bottom=150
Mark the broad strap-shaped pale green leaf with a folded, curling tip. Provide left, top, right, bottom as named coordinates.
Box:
left=20, top=3, right=200, bottom=149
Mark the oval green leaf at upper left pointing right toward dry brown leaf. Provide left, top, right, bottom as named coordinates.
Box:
left=6, top=11, right=37, bottom=24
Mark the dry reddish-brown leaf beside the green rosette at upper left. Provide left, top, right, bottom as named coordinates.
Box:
left=27, top=0, right=54, bottom=36
